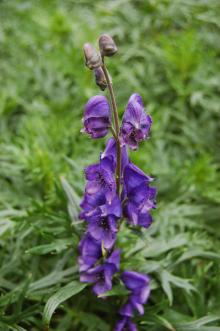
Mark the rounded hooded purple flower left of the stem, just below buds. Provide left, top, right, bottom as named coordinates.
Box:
left=82, top=95, right=111, bottom=139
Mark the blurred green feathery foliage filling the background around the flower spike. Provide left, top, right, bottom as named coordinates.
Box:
left=0, top=0, right=220, bottom=331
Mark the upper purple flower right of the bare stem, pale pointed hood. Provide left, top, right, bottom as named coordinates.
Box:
left=121, top=93, right=152, bottom=150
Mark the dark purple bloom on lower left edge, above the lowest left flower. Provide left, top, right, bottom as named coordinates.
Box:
left=78, top=233, right=102, bottom=272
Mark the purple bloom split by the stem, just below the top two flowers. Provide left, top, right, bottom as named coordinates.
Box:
left=101, top=138, right=129, bottom=177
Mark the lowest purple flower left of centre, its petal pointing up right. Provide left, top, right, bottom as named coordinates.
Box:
left=80, top=249, right=120, bottom=295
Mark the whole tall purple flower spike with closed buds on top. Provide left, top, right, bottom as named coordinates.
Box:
left=79, top=35, right=156, bottom=331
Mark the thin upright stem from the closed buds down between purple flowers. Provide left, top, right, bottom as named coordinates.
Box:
left=102, top=58, right=121, bottom=195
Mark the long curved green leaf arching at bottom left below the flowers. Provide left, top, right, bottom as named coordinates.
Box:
left=43, top=281, right=86, bottom=325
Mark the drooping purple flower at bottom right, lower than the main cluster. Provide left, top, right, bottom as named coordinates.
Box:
left=119, top=271, right=150, bottom=317
